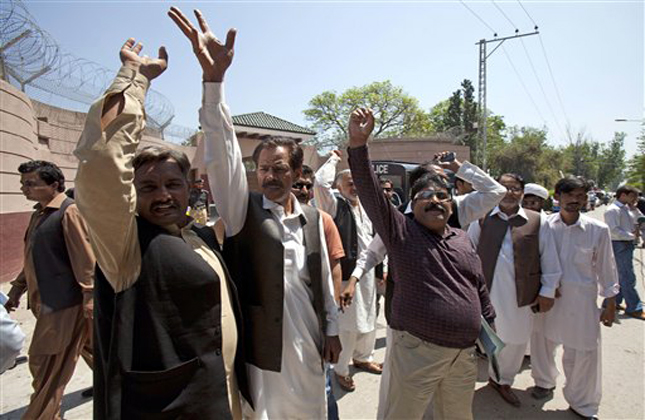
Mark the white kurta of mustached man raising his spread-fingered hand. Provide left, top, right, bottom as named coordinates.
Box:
left=200, top=83, right=338, bottom=419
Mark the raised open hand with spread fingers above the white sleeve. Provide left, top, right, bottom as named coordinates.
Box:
left=168, top=7, right=237, bottom=82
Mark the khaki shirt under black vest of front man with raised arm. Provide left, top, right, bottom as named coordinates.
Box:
left=74, top=67, right=241, bottom=418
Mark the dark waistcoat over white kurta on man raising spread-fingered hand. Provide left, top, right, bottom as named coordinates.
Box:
left=223, top=192, right=327, bottom=372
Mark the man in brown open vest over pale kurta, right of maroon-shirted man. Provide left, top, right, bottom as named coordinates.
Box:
left=468, top=174, right=562, bottom=407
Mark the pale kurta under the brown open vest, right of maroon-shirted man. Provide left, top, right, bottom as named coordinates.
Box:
left=468, top=207, right=562, bottom=344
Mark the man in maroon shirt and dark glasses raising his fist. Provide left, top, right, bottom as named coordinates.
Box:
left=348, top=109, right=495, bottom=420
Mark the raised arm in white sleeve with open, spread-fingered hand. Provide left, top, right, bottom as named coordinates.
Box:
left=168, top=7, right=249, bottom=236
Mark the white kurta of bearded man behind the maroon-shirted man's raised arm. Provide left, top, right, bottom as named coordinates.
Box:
left=314, top=155, right=376, bottom=334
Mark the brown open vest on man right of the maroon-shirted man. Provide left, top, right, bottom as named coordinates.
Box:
left=477, top=209, right=542, bottom=307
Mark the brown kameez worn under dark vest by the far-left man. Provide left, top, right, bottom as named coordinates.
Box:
left=11, top=193, right=96, bottom=355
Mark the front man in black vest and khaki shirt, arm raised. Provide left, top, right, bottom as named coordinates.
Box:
left=75, top=38, right=249, bottom=419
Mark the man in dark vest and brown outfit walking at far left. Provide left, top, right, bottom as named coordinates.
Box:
left=5, top=160, right=95, bottom=420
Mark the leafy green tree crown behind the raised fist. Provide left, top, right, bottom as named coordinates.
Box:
left=303, top=80, right=434, bottom=147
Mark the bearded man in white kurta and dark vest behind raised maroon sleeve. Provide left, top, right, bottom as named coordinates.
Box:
left=314, top=150, right=383, bottom=392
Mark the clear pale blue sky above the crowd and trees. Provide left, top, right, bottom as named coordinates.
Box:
left=12, top=0, right=645, bottom=156
